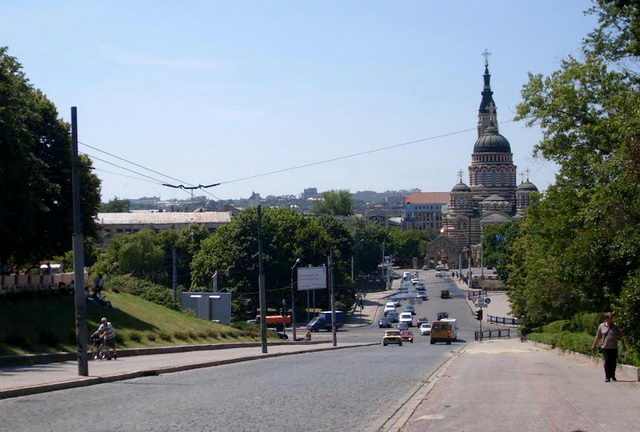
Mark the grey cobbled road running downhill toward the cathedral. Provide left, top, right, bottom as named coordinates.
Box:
left=0, top=271, right=490, bottom=432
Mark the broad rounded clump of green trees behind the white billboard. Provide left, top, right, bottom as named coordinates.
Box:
left=191, top=209, right=354, bottom=316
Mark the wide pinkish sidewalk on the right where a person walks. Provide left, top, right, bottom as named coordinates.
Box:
left=402, top=339, right=640, bottom=432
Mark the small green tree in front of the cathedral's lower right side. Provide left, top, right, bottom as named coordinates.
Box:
left=482, top=222, right=519, bottom=281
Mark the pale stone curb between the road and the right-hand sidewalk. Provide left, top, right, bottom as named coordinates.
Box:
left=365, top=343, right=469, bottom=432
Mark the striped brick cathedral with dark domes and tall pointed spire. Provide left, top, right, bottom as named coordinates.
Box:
left=427, top=61, right=538, bottom=262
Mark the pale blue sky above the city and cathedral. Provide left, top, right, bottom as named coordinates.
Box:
left=0, top=0, right=595, bottom=201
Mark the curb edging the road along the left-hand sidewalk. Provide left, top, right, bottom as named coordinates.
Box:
left=0, top=342, right=379, bottom=399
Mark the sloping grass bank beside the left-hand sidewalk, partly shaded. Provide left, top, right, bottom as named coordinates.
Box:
left=0, top=292, right=276, bottom=355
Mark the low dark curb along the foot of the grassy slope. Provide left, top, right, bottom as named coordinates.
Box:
left=0, top=341, right=325, bottom=367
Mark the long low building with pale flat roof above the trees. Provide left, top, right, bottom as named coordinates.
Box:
left=96, top=212, right=232, bottom=243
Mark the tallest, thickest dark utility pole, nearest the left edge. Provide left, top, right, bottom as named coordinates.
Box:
left=71, top=107, right=89, bottom=376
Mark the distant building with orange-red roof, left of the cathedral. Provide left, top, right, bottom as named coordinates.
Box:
left=403, top=192, right=449, bottom=232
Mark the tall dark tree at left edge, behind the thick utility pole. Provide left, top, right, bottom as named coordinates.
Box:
left=0, top=47, right=100, bottom=266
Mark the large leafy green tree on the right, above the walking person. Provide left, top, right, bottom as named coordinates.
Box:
left=508, top=0, right=640, bottom=331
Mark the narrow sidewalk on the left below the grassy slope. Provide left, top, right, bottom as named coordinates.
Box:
left=0, top=343, right=377, bottom=399
